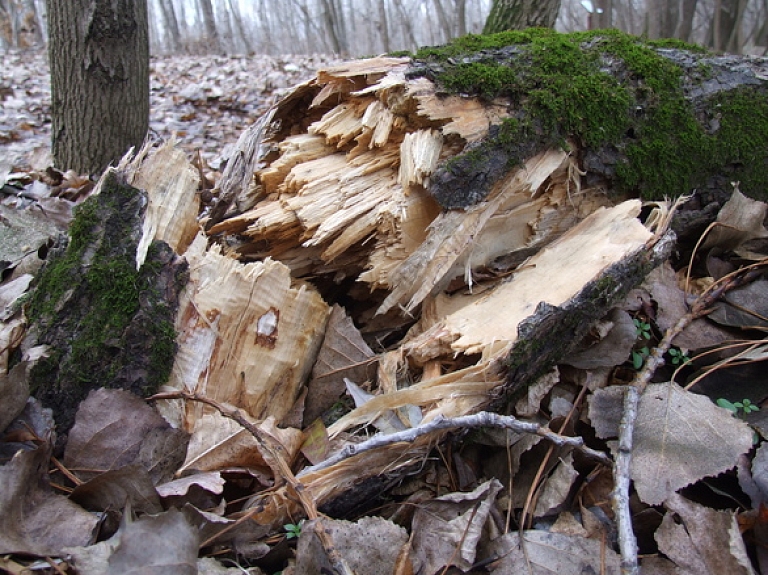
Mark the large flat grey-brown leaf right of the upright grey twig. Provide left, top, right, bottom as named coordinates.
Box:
left=631, top=383, right=752, bottom=505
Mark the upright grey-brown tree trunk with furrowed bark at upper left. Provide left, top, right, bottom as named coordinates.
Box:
left=47, top=0, right=149, bottom=173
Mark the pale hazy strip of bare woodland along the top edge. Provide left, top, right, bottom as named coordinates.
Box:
left=0, top=0, right=768, bottom=57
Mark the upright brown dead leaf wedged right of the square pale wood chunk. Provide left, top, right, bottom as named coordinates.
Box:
left=304, top=304, right=374, bottom=425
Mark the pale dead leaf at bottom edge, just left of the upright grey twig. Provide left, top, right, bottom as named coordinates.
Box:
left=489, top=530, right=620, bottom=575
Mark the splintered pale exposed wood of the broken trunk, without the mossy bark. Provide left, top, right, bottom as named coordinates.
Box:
left=124, top=58, right=657, bottom=523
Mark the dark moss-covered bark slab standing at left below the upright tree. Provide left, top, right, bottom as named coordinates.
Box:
left=27, top=172, right=187, bottom=446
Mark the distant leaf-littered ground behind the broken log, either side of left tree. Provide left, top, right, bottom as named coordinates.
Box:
left=0, top=51, right=340, bottom=180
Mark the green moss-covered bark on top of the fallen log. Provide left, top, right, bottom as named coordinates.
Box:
left=410, top=29, right=768, bottom=208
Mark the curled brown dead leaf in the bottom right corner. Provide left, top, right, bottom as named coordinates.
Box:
left=655, top=493, right=754, bottom=575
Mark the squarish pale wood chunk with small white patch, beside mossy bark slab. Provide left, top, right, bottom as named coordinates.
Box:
left=160, top=236, right=329, bottom=430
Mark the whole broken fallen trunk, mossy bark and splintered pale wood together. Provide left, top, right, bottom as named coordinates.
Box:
left=22, top=31, right=768, bottom=526
